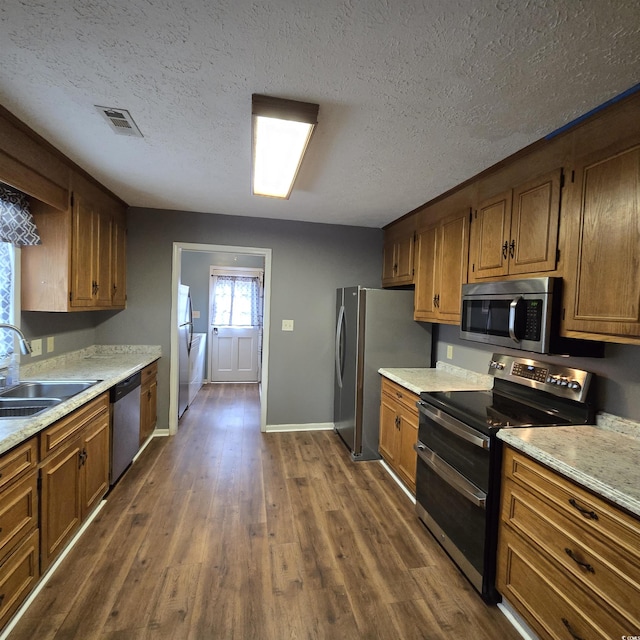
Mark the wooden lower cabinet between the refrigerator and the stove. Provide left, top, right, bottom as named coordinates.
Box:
left=379, top=378, right=419, bottom=493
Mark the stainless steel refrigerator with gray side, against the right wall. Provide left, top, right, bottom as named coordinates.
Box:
left=333, top=287, right=431, bottom=460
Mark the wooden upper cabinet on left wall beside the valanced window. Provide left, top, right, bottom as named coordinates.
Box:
left=22, top=173, right=126, bottom=311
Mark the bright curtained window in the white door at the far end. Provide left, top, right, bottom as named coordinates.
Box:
left=211, top=275, right=261, bottom=327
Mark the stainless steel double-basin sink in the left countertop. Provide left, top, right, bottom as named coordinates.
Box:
left=0, top=380, right=99, bottom=418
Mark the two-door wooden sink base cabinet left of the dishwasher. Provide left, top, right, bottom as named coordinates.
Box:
left=40, top=393, right=109, bottom=571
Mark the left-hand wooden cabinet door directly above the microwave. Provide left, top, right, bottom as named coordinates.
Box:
left=469, top=190, right=512, bottom=280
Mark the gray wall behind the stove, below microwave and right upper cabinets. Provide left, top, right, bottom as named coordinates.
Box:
left=433, top=325, right=640, bottom=420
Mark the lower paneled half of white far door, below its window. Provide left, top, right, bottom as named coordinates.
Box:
left=210, top=327, right=259, bottom=382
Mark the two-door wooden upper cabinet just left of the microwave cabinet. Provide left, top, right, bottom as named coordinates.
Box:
left=414, top=209, right=469, bottom=324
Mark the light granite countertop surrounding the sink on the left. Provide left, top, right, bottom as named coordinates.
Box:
left=0, top=345, right=162, bottom=454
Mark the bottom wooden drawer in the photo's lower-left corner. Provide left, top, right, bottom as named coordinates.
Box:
left=0, top=529, right=40, bottom=627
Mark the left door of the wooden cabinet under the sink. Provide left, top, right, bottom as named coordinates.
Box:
left=40, top=440, right=82, bottom=571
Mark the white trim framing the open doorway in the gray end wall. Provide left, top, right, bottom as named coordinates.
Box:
left=169, top=242, right=272, bottom=435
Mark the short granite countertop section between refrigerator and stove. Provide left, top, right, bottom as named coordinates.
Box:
left=378, top=362, right=493, bottom=395
